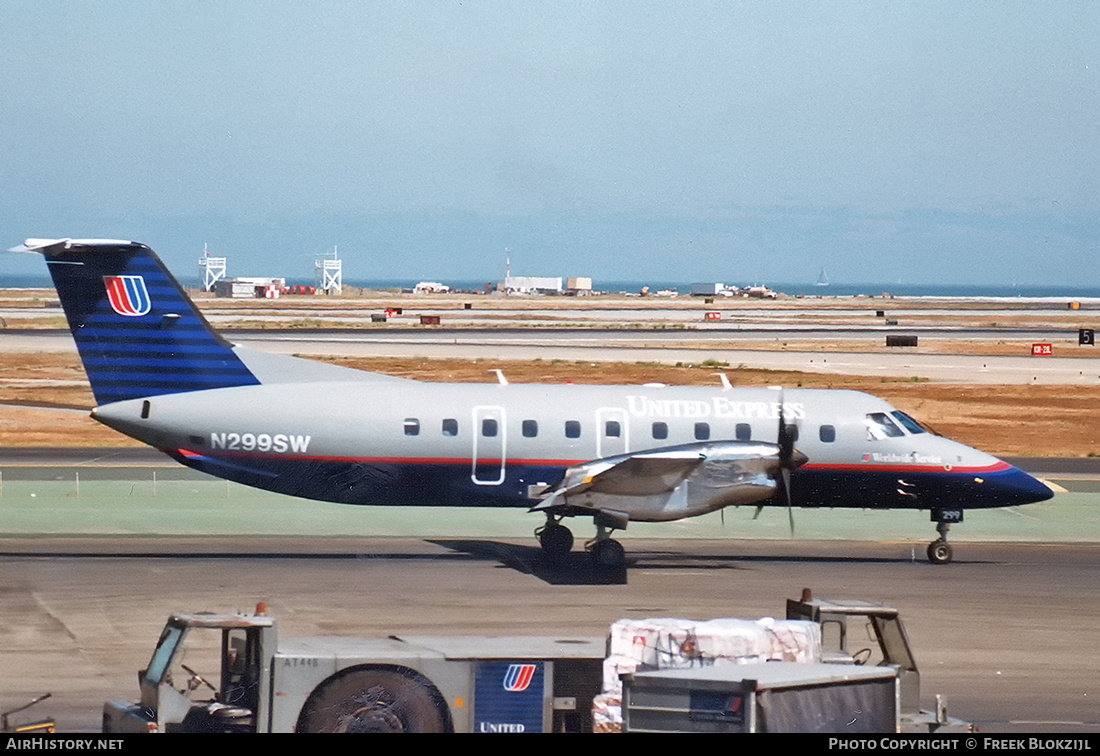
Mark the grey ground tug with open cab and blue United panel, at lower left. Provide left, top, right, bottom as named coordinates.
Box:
left=103, top=607, right=605, bottom=733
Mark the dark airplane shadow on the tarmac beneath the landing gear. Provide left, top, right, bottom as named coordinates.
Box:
left=428, top=538, right=927, bottom=585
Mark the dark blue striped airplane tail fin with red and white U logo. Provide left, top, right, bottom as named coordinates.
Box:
left=14, top=239, right=260, bottom=404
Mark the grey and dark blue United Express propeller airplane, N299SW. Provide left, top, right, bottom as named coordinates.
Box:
left=12, top=239, right=1053, bottom=567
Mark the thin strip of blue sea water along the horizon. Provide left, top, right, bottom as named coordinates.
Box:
left=0, top=274, right=1100, bottom=299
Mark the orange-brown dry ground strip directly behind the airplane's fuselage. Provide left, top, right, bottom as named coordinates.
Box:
left=0, top=354, right=1100, bottom=457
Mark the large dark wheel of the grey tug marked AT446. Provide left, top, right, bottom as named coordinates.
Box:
left=296, top=666, right=452, bottom=733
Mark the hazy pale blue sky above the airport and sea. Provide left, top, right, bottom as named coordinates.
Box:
left=0, top=0, right=1100, bottom=284
